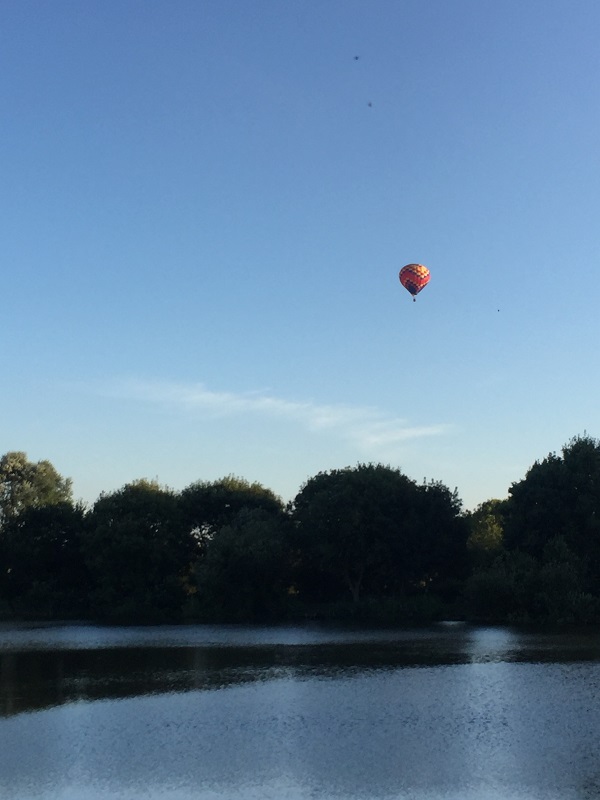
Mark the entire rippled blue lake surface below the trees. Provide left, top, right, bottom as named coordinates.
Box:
left=0, top=623, right=600, bottom=800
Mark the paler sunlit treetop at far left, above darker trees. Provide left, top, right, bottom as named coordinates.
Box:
left=0, top=451, right=72, bottom=524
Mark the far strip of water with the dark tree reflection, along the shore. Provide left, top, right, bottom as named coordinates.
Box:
left=0, top=623, right=600, bottom=716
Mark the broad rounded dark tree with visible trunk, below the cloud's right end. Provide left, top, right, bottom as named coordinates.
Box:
left=292, top=464, right=466, bottom=602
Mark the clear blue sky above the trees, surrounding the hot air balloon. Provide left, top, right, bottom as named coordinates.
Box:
left=0, top=0, right=600, bottom=508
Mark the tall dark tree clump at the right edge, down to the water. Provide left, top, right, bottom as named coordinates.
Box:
left=465, top=435, right=600, bottom=624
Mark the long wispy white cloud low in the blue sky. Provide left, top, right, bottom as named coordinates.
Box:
left=99, top=380, right=450, bottom=454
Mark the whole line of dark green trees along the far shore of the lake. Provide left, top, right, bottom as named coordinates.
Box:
left=0, top=434, right=600, bottom=624
